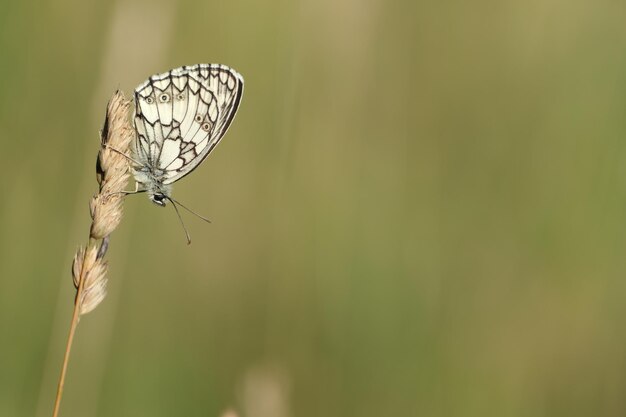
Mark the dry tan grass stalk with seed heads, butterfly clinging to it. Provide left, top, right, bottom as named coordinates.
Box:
left=52, top=91, right=134, bottom=417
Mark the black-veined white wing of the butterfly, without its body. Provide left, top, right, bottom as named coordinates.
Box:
left=135, top=64, right=243, bottom=184
